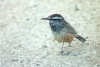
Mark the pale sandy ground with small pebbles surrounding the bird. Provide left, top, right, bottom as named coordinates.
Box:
left=0, top=0, right=100, bottom=67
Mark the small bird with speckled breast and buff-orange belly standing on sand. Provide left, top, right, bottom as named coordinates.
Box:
left=41, top=14, right=86, bottom=53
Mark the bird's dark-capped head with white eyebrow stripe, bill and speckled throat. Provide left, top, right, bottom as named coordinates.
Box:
left=42, top=14, right=64, bottom=30
